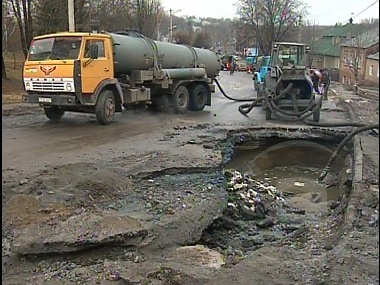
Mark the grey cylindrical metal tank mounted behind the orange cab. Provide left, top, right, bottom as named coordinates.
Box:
left=108, top=33, right=220, bottom=78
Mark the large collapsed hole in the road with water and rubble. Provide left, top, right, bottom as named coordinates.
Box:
left=201, top=131, right=351, bottom=263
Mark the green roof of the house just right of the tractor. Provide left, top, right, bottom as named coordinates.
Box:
left=312, top=23, right=357, bottom=57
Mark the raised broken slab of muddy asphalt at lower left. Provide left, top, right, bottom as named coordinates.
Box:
left=13, top=213, right=148, bottom=255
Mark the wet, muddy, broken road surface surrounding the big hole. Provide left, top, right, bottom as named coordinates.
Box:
left=2, top=72, right=378, bottom=285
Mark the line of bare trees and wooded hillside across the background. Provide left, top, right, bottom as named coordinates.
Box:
left=2, top=0, right=378, bottom=79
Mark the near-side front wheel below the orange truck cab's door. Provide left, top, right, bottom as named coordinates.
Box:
left=95, top=90, right=115, bottom=125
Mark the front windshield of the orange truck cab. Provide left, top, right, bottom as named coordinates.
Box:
left=28, top=37, right=82, bottom=61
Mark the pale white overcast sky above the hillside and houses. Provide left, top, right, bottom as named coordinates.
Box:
left=161, top=0, right=379, bottom=25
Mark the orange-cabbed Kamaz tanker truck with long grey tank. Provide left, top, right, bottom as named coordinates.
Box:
left=23, top=32, right=220, bottom=125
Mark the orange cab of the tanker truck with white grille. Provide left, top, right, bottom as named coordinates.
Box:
left=23, top=33, right=119, bottom=123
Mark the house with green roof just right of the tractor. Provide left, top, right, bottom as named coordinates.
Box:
left=311, top=21, right=356, bottom=69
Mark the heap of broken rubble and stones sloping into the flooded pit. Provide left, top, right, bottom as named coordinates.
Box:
left=200, top=171, right=310, bottom=260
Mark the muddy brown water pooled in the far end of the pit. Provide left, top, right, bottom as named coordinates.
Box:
left=225, top=138, right=347, bottom=201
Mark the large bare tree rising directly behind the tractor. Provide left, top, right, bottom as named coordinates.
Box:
left=237, top=0, right=306, bottom=54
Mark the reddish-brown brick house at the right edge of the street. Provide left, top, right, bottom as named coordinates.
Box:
left=339, top=28, right=379, bottom=85
